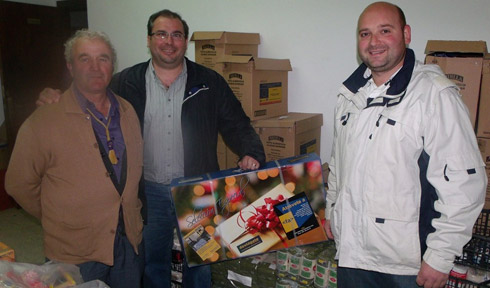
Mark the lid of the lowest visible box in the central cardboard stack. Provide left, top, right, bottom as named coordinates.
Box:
left=253, top=112, right=323, bottom=134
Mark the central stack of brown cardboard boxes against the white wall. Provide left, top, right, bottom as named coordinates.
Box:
left=191, top=31, right=323, bottom=169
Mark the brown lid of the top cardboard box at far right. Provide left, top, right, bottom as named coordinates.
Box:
left=425, top=40, right=487, bottom=54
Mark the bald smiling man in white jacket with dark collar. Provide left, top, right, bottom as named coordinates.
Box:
left=325, top=2, right=487, bottom=288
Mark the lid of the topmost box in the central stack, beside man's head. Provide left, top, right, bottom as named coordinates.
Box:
left=191, top=31, right=260, bottom=45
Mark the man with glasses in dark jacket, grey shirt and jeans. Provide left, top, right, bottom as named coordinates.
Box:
left=38, top=10, right=265, bottom=287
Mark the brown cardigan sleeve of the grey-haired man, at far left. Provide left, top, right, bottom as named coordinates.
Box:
left=5, top=118, right=46, bottom=218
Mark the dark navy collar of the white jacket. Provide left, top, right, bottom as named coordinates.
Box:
left=343, top=48, right=415, bottom=99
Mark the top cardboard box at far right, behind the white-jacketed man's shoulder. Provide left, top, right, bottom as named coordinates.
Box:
left=425, top=40, right=487, bottom=128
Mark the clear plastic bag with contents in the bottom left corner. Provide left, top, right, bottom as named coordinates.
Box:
left=0, top=261, right=83, bottom=288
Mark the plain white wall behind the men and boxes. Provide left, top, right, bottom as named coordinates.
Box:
left=88, top=0, right=490, bottom=162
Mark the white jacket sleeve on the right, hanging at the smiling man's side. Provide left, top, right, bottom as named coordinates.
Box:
left=423, top=87, right=487, bottom=273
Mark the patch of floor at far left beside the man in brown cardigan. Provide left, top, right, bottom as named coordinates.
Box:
left=0, top=208, right=45, bottom=264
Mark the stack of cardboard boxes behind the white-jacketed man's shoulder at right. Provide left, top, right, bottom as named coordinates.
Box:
left=425, top=40, right=490, bottom=209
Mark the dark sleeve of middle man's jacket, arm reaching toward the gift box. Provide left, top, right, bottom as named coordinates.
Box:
left=217, top=77, right=265, bottom=165
